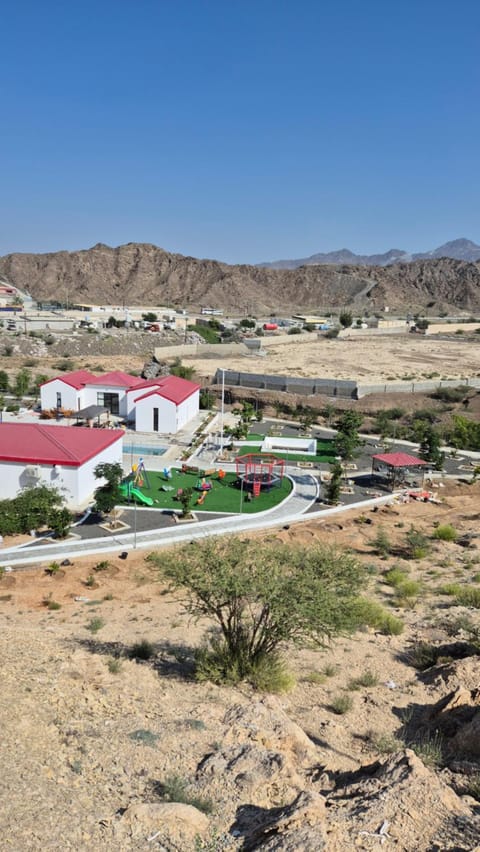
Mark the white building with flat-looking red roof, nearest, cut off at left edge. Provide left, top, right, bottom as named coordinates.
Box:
left=0, top=423, right=124, bottom=509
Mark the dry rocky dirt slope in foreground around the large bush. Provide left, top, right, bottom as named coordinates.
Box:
left=0, top=483, right=480, bottom=852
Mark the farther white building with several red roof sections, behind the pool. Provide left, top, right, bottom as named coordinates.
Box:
left=40, top=370, right=200, bottom=434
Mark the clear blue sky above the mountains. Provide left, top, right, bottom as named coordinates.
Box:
left=0, top=0, right=480, bottom=263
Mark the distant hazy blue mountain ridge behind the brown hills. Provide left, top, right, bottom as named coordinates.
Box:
left=259, top=238, right=480, bottom=269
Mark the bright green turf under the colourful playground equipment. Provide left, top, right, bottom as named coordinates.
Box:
left=120, top=468, right=292, bottom=514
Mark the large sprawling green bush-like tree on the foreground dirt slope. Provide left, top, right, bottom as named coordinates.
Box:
left=149, top=537, right=364, bottom=681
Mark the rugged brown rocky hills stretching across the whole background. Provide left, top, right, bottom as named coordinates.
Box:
left=0, top=243, right=480, bottom=315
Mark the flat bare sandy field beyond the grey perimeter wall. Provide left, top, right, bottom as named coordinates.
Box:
left=184, top=335, right=480, bottom=382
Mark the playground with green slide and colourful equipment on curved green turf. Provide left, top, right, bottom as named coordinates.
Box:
left=121, top=463, right=292, bottom=514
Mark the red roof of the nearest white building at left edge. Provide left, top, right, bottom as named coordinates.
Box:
left=0, top=423, right=123, bottom=467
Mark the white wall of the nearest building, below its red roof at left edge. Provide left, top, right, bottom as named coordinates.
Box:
left=0, top=435, right=123, bottom=509
